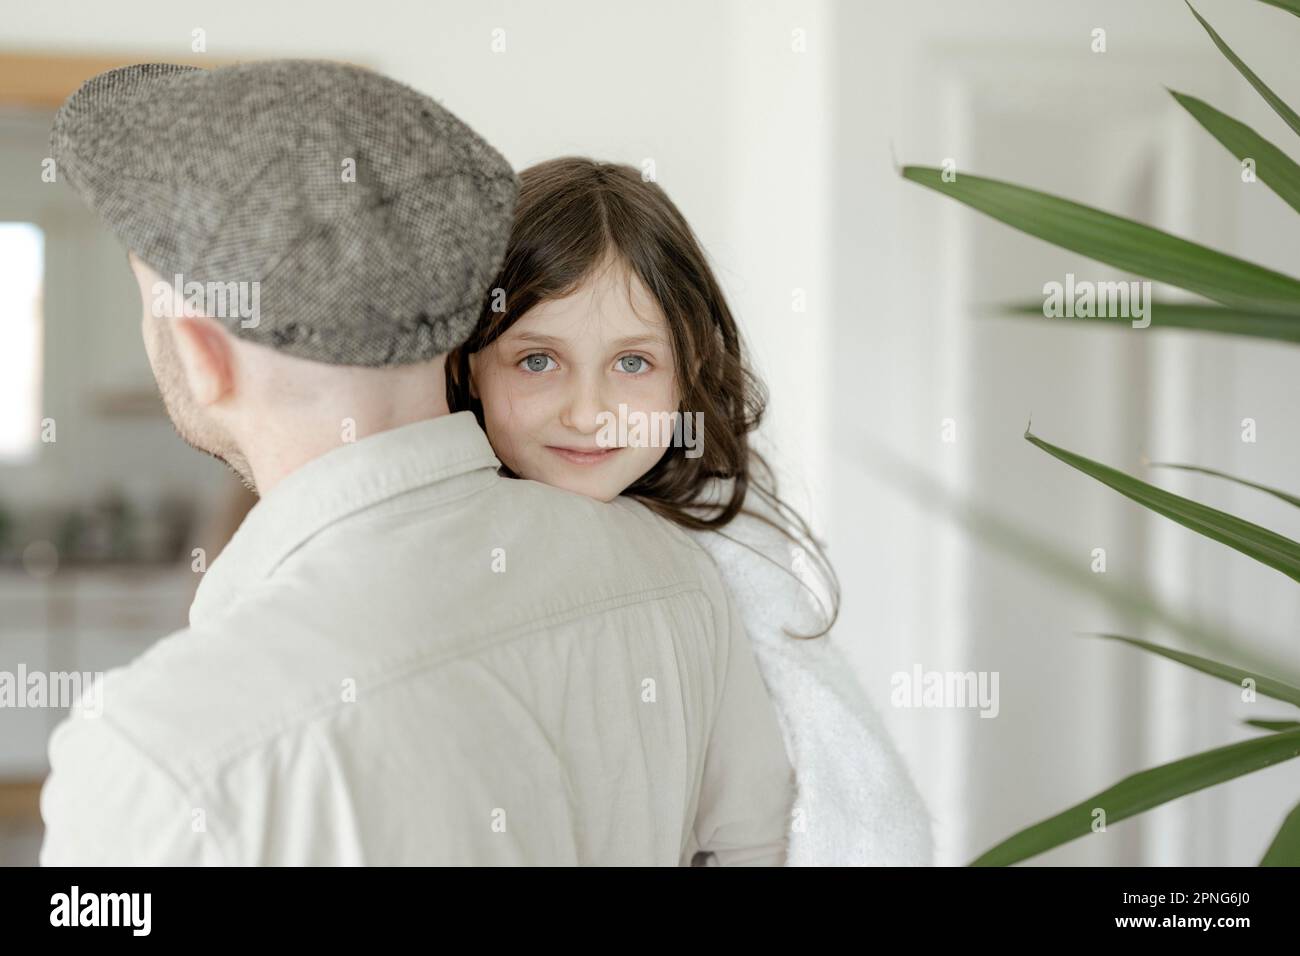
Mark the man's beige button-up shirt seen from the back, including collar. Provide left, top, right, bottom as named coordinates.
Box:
left=40, top=412, right=794, bottom=865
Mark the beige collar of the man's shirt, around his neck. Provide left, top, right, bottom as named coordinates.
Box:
left=190, top=411, right=501, bottom=627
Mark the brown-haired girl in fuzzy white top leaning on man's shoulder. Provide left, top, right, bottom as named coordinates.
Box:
left=447, top=157, right=931, bottom=865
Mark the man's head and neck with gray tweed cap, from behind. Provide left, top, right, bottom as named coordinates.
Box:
left=51, top=60, right=517, bottom=494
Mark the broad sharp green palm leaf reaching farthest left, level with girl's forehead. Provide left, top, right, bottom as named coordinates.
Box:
left=902, top=166, right=1300, bottom=316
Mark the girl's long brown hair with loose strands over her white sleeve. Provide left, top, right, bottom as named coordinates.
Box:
left=446, top=156, right=840, bottom=637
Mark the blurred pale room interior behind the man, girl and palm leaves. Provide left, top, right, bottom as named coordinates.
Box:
left=0, top=0, right=1300, bottom=865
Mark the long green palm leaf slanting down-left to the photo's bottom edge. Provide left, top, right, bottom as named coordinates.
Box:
left=970, top=730, right=1300, bottom=866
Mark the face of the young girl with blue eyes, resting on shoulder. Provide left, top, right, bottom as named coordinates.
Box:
left=469, top=257, right=679, bottom=501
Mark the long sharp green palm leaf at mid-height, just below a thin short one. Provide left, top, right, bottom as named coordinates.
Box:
left=1024, top=429, right=1300, bottom=581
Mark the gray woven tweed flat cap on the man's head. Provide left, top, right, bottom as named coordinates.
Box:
left=51, top=60, right=519, bottom=365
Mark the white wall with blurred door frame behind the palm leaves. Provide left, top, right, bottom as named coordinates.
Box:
left=832, top=0, right=1300, bottom=864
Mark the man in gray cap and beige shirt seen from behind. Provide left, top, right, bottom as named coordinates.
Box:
left=40, top=61, right=793, bottom=865
